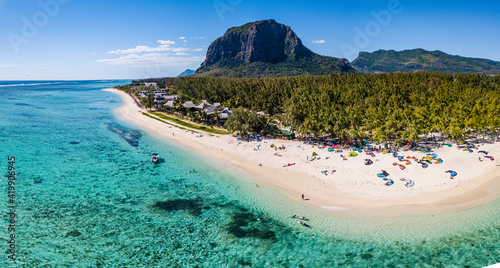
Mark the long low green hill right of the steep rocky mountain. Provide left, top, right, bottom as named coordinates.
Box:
left=351, top=49, right=500, bottom=74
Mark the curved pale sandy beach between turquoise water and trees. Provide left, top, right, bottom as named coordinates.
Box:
left=104, top=89, right=500, bottom=216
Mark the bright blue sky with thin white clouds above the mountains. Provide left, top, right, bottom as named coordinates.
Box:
left=0, top=0, right=500, bottom=80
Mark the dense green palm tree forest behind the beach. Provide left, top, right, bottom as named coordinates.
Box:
left=130, top=72, right=500, bottom=144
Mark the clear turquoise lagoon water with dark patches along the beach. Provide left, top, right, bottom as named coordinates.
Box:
left=0, top=81, right=500, bottom=267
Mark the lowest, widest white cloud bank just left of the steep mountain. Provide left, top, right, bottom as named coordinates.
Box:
left=97, top=53, right=205, bottom=67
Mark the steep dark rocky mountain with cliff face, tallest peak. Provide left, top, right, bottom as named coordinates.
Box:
left=195, top=20, right=355, bottom=77
